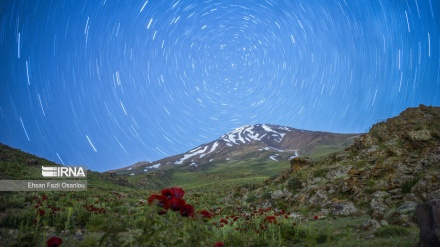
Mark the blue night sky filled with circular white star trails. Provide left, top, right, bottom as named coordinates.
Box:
left=0, top=0, right=440, bottom=171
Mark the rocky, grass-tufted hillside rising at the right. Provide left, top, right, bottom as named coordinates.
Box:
left=225, top=105, right=440, bottom=231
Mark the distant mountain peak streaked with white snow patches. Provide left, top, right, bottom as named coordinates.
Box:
left=109, top=124, right=359, bottom=175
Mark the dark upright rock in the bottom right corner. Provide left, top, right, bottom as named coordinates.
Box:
left=416, top=199, right=440, bottom=246
